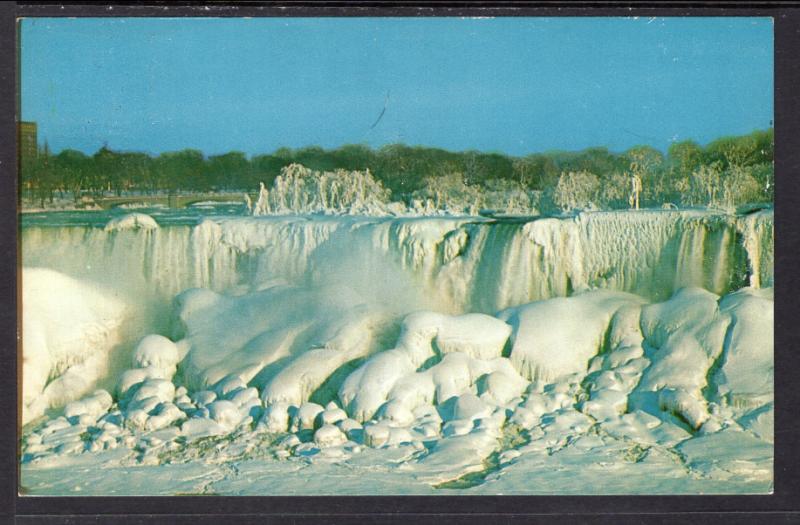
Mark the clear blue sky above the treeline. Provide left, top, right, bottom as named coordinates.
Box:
left=21, top=18, right=773, bottom=155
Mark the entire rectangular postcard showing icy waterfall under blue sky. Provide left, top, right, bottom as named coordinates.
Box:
left=18, top=16, right=775, bottom=496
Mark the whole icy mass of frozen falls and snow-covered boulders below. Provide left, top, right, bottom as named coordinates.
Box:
left=22, top=208, right=774, bottom=493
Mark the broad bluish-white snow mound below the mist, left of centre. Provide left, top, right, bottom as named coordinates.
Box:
left=176, top=286, right=386, bottom=406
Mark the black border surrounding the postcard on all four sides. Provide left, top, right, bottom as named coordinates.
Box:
left=6, top=2, right=800, bottom=524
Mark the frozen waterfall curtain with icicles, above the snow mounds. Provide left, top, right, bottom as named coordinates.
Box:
left=22, top=211, right=773, bottom=313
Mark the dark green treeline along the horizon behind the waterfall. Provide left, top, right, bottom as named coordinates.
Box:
left=21, top=128, right=774, bottom=209
